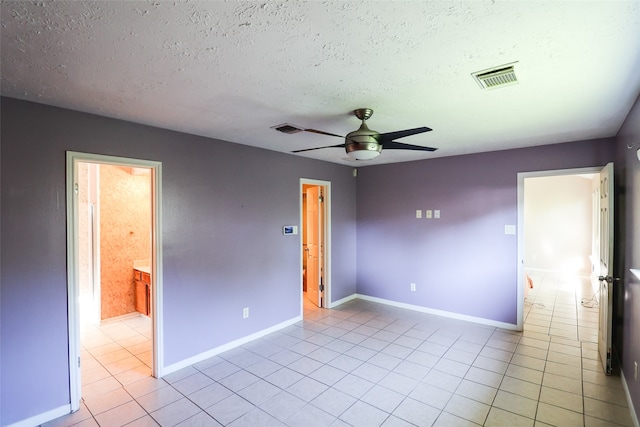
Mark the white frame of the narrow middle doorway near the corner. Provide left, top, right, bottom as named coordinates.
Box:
left=298, top=178, right=332, bottom=316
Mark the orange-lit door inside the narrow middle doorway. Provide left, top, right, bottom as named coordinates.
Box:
left=305, top=186, right=322, bottom=307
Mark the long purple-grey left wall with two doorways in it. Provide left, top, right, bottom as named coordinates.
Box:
left=0, top=98, right=356, bottom=425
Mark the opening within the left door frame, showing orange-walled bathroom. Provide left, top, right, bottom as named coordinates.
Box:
left=77, top=162, right=153, bottom=372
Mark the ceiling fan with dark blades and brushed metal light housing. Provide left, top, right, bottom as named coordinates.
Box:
left=292, top=108, right=437, bottom=160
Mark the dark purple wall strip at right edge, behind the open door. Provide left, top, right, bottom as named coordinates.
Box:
left=616, top=93, right=640, bottom=418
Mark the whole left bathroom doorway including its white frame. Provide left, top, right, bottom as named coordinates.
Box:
left=67, top=152, right=161, bottom=410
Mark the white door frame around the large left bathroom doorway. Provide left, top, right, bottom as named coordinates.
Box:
left=66, top=151, right=164, bottom=412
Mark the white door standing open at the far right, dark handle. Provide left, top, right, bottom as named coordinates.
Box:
left=598, top=163, right=615, bottom=375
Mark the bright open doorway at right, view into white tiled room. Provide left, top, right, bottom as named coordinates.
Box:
left=524, top=173, right=599, bottom=344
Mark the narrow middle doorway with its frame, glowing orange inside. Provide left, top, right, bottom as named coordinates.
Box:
left=300, top=179, right=331, bottom=312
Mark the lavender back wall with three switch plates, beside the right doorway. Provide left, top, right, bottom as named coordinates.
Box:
left=357, top=139, right=615, bottom=324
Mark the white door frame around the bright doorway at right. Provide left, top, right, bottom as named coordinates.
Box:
left=516, top=167, right=602, bottom=331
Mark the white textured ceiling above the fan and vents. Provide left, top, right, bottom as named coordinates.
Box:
left=0, top=0, right=640, bottom=166
